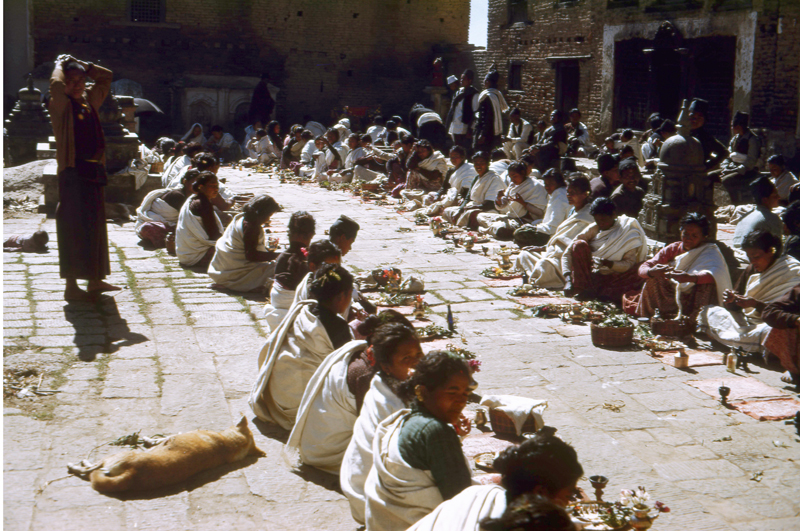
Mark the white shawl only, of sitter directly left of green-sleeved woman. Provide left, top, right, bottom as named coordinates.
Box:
left=339, top=373, right=405, bottom=525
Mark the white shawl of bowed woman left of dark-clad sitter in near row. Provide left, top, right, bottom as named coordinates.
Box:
left=208, top=214, right=275, bottom=292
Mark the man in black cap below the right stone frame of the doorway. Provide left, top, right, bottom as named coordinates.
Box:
left=722, top=111, right=761, bottom=205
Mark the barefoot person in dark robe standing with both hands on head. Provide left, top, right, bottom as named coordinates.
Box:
left=49, top=55, right=122, bottom=301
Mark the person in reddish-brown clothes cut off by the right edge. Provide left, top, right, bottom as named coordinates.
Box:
left=761, top=285, right=800, bottom=389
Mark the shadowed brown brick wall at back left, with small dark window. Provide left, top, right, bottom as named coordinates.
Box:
left=31, top=0, right=469, bottom=135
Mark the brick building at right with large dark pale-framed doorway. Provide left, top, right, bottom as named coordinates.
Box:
left=481, top=0, right=800, bottom=151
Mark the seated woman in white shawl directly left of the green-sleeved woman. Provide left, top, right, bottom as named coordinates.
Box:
left=339, top=325, right=422, bottom=525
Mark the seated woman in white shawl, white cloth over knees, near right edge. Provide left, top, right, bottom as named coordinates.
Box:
left=697, top=230, right=800, bottom=352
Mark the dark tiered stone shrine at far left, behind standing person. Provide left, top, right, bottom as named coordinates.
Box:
left=3, top=74, right=53, bottom=166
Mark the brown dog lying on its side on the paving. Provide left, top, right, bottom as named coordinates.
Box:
left=67, top=417, right=267, bottom=494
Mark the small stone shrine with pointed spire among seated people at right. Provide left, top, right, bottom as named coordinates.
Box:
left=639, top=100, right=717, bottom=243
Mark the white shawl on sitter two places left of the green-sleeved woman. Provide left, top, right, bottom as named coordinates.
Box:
left=284, top=341, right=367, bottom=474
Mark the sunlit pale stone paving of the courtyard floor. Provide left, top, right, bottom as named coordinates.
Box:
left=3, top=169, right=800, bottom=531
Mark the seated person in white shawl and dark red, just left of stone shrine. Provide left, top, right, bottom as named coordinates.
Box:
left=561, top=197, right=647, bottom=302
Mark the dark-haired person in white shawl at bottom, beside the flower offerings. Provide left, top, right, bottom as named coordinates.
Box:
left=409, top=426, right=583, bottom=531
